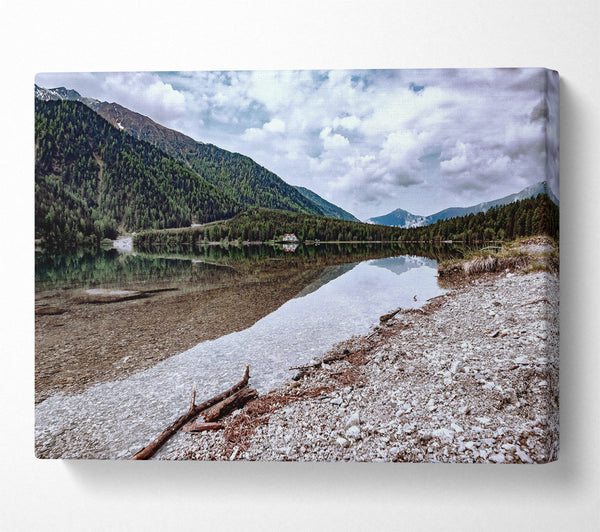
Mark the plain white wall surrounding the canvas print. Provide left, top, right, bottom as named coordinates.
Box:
left=0, top=0, right=600, bottom=531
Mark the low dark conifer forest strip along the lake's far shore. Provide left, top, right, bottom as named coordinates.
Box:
left=135, top=194, right=559, bottom=250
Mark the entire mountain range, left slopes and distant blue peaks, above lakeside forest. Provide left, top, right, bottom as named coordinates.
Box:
left=35, top=85, right=558, bottom=246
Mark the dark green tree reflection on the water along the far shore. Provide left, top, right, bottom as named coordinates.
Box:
left=35, top=243, right=464, bottom=291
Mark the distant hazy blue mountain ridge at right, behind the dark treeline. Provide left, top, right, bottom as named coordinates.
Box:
left=367, top=181, right=559, bottom=228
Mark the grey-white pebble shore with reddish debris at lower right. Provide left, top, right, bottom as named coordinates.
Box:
left=162, top=271, right=559, bottom=463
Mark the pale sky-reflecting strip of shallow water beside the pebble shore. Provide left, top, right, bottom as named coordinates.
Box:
left=36, top=256, right=443, bottom=458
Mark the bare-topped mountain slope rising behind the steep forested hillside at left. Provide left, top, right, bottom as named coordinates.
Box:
left=35, top=85, right=325, bottom=215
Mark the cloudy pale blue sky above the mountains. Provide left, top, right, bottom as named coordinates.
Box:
left=36, top=69, right=559, bottom=220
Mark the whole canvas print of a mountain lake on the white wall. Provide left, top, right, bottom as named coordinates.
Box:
left=35, top=68, right=559, bottom=464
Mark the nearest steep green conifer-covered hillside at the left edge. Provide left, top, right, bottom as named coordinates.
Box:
left=35, top=100, right=240, bottom=247
